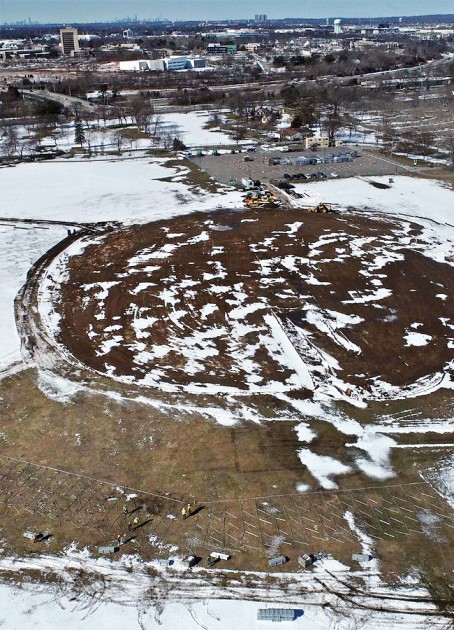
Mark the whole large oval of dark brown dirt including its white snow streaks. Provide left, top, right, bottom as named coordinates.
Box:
left=57, top=210, right=454, bottom=397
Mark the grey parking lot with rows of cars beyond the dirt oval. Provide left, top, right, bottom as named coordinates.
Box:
left=192, top=146, right=408, bottom=188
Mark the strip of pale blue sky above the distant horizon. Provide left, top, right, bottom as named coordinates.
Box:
left=0, top=0, right=454, bottom=23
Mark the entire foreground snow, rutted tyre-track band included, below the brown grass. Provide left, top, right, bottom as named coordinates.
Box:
left=0, top=548, right=446, bottom=630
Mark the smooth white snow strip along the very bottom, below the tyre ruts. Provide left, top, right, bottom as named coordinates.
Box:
left=0, top=584, right=446, bottom=630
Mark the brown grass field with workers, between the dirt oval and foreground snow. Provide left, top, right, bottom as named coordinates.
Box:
left=0, top=371, right=454, bottom=589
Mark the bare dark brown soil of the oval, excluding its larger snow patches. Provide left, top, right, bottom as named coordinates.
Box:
left=55, top=210, right=454, bottom=388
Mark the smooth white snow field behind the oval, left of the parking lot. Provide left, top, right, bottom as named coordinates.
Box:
left=0, top=158, right=245, bottom=223
